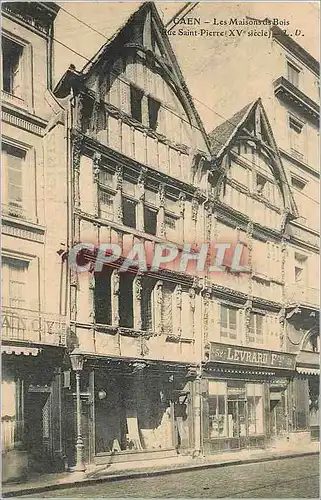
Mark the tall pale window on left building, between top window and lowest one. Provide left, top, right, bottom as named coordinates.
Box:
left=2, top=143, right=26, bottom=217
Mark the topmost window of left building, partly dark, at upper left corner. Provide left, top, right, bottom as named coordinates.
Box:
left=2, top=37, right=23, bottom=98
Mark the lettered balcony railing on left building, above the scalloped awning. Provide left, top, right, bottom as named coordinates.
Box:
left=2, top=306, right=66, bottom=346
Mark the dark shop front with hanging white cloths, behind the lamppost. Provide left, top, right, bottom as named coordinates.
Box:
left=64, top=359, right=195, bottom=467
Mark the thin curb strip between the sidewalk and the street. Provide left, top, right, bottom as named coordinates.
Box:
left=2, top=451, right=319, bottom=498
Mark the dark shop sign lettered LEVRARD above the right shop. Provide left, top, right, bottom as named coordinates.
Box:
left=210, top=342, right=295, bottom=370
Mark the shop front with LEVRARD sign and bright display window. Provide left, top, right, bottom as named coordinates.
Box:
left=202, top=343, right=295, bottom=454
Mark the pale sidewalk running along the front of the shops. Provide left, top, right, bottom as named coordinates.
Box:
left=2, top=442, right=319, bottom=497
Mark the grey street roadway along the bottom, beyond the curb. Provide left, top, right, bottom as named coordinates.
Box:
left=22, top=455, right=319, bottom=498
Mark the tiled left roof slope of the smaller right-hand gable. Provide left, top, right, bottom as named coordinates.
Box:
left=209, top=101, right=257, bottom=157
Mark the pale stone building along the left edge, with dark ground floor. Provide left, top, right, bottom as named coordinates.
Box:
left=1, top=2, right=65, bottom=481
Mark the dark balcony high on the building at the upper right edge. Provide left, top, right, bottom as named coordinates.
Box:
left=273, top=76, right=319, bottom=122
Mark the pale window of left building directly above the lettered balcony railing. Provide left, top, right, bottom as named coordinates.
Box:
left=1, top=257, right=29, bottom=309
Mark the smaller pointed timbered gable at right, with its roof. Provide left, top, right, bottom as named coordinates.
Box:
left=210, top=99, right=298, bottom=225
